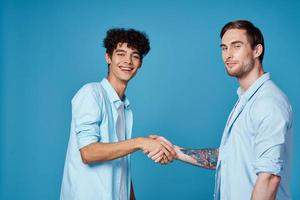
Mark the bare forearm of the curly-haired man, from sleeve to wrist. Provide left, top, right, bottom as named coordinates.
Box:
left=80, top=138, right=142, bottom=164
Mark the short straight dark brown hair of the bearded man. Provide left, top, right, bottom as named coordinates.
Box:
left=220, top=20, right=265, bottom=63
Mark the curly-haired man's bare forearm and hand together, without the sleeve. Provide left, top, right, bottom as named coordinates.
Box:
left=80, top=137, right=176, bottom=164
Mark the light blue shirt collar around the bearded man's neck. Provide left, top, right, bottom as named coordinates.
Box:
left=237, top=73, right=271, bottom=101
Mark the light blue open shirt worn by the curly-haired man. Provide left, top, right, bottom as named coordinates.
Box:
left=60, top=79, right=132, bottom=200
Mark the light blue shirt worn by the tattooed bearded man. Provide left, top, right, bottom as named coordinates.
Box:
left=215, top=73, right=293, bottom=200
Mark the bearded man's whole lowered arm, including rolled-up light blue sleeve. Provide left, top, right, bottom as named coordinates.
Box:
left=251, top=98, right=292, bottom=200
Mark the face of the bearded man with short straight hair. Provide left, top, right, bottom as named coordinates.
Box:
left=221, top=29, right=258, bottom=78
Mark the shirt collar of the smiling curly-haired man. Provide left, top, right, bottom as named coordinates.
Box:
left=100, top=78, right=130, bottom=108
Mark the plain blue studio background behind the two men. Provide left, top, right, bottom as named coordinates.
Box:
left=0, top=0, right=300, bottom=200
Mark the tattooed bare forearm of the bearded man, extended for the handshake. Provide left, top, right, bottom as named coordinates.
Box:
left=175, top=146, right=219, bottom=169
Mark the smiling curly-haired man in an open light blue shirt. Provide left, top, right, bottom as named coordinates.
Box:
left=60, top=29, right=176, bottom=200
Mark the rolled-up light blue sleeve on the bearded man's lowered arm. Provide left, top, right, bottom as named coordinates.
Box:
left=254, top=98, right=289, bottom=176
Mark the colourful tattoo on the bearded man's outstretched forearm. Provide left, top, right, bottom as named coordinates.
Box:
left=180, top=149, right=219, bottom=169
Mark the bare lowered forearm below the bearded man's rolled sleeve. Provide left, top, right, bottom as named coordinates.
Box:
left=251, top=173, right=280, bottom=200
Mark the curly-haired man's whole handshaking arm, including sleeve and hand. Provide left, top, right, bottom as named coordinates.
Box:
left=72, top=84, right=175, bottom=164
